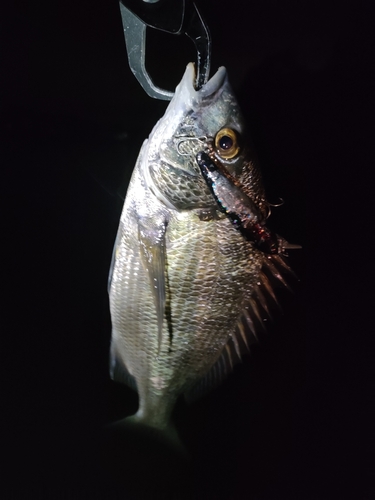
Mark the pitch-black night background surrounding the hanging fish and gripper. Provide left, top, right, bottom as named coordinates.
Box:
left=0, top=0, right=375, bottom=500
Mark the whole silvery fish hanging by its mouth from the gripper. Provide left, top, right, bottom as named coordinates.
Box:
left=108, top=63, right=296, bottom=438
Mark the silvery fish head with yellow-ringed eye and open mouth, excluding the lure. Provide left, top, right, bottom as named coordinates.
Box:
left=145, top=63, right=266, bottom=215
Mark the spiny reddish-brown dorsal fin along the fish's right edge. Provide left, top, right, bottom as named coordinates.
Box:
left=185, top=255, right=295, bottom=402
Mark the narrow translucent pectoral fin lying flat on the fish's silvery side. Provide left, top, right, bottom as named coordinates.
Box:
left=138, top=222, right=167, bottom=352
